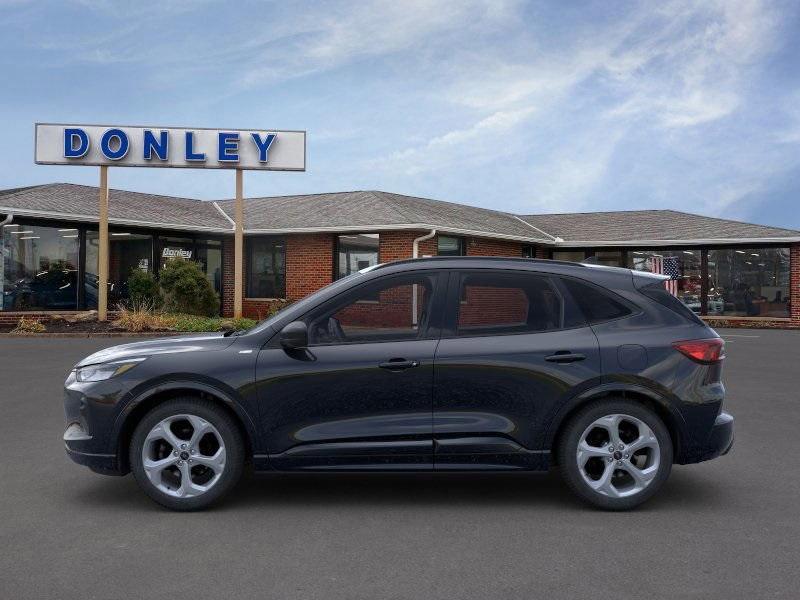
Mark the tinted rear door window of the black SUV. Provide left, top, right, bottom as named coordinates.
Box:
left=456, top=273, right=563, bottom=336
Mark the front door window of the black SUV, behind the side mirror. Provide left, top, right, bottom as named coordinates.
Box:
left=309, top=274, right=434, bottom=344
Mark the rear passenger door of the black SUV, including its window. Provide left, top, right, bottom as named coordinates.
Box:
left=433, top=270, right=601, bottom=469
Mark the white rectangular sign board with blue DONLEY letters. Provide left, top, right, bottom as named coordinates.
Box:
left=35, top=123, right=306, bottom=171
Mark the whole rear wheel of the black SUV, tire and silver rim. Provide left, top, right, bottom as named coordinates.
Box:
left=557, top=398, right=673, bottom=510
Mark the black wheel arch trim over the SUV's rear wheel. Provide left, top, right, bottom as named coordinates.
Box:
left=544, top=384, right=685, bottom=464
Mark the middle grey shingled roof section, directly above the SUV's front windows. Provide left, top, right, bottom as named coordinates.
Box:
left=212, top=191, right=552, bottom=242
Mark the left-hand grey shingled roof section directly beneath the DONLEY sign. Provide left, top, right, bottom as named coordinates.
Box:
left=0, top=183, right=231, bottom=231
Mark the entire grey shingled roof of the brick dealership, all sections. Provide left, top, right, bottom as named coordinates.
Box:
left=0, top=183, right=800, bottom=247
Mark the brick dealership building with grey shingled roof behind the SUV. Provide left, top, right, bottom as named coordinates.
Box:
left=0, top=183, right=800, bottom=327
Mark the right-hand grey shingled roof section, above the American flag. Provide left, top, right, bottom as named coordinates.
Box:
left=521, top=210, right=800, bottom=246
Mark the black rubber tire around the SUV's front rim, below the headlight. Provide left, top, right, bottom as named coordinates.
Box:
left=129, top=397, right=245, bottom=511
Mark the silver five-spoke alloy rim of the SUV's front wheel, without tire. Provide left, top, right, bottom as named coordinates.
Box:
left=142, top=414, right=226, bottom=498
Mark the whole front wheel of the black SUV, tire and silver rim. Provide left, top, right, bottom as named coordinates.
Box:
left=130, top=398, right=244, bottom=510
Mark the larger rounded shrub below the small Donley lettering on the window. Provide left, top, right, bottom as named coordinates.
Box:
left=160, top=258, right=219, bottom=316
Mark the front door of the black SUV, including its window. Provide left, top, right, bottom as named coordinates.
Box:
left=256, top=273, right=444, bottom=469
